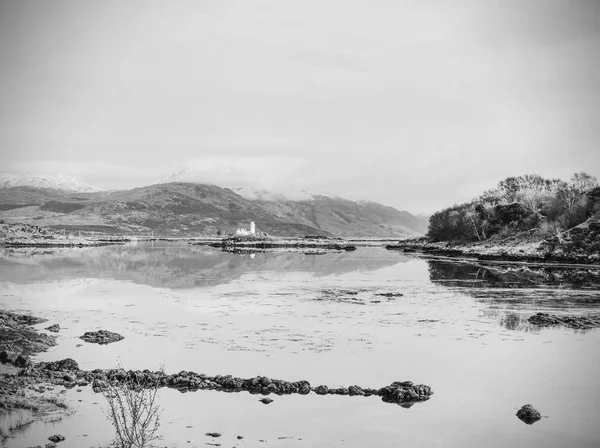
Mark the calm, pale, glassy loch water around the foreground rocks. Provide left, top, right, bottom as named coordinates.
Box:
left=0, top=243, right=600, bottom=448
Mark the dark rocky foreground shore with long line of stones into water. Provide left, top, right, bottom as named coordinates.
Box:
left=0, top=310, right=433, bottom=439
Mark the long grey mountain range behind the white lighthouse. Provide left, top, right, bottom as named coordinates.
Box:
left=0, top=183, right=424, bottom=238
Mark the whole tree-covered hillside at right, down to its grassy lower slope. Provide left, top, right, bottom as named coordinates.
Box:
left=427, top=173, right=600, bottom=256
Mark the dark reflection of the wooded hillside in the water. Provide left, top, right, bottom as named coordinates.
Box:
left=427, top=260, right=600, bottom=331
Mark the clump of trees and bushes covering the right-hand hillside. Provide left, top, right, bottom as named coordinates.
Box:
left=427, top=172, right=600, bottom=242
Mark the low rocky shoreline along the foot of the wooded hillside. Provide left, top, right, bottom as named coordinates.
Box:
left=385, top=238, right=600, bottom=264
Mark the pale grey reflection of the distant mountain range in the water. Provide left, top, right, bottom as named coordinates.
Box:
left=0, top=243, right=404, bottom=288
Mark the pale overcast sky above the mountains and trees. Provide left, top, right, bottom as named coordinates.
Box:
left=0, top=0, right=600, bottom=213
